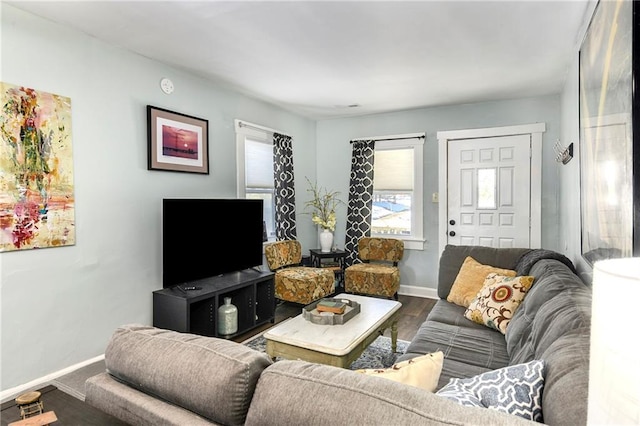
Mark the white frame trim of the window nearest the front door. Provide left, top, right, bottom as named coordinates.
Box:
left=368, top=133, right=425, bottom=250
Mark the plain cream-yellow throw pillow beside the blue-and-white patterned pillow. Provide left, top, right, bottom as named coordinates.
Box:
left=355, top=351, right=444, bottom=392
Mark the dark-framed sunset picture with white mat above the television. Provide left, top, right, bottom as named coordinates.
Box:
left=147, top=105, right=209, bottom=175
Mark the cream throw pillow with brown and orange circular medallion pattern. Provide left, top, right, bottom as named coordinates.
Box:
left=464, top=273, right=534, bottom=334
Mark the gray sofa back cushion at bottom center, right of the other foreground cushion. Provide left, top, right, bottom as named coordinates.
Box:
left=246, top=361, right=534, bottom=426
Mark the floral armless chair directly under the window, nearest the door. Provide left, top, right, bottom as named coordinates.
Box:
left=344, top=237, right=404, bottom=300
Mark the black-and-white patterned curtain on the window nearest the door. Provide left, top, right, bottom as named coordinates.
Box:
left=344, top=140, right=375, bottom=266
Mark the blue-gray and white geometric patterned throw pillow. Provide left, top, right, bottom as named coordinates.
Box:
left=436, top=360, right=544, bottom=422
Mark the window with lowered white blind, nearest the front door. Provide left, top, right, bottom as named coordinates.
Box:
left=371, top=135, right=424, bottom=250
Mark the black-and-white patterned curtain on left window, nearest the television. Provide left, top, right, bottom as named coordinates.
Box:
left=273, top=133, right=296, bottom=241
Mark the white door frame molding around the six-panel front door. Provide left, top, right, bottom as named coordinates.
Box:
left=437, top=123, right=546, bottom=253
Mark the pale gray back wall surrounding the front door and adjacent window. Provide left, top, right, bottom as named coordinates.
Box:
left=316, top=95, right=560, bottom=294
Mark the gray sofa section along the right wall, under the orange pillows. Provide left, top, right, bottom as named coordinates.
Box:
left=398, top=245, right=591, bottom=425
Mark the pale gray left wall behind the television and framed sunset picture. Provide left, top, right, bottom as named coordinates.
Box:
left=0, top=3, right=316, bottom=390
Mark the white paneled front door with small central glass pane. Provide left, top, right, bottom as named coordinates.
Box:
left=447, top=135, right=531, bottom=247
